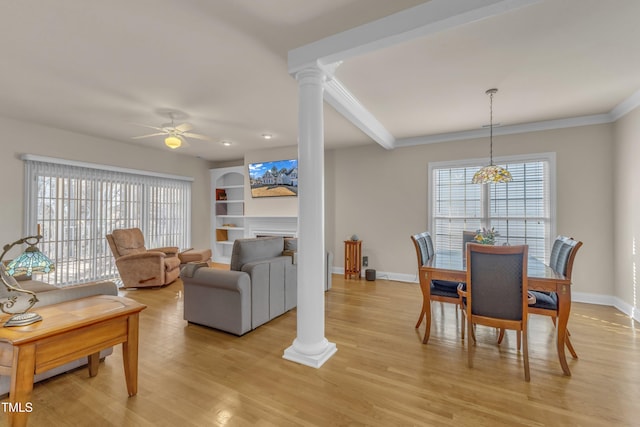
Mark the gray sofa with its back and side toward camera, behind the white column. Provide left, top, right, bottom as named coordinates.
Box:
left=181, top=237, right=331, bottom=335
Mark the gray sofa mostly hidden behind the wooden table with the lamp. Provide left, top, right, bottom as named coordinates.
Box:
left=0, top=280, right=118, bottom=396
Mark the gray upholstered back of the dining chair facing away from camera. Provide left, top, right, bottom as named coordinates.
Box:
left=467, top=243, right=527, bottom=320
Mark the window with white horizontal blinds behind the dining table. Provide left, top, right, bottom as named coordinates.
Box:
left=429, top=153, right=555, bottom=260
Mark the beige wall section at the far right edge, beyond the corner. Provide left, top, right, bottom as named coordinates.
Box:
left=612, top=108, right=640, bottom=318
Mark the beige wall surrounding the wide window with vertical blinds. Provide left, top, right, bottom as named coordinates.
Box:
left=0, top=118, right=211, bottom=260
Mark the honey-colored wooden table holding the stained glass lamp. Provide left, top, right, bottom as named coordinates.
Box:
left=0, top=295, right=146, bottom=426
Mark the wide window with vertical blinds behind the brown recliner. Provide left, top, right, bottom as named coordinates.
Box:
left=23, top=156, right=191, bottom=285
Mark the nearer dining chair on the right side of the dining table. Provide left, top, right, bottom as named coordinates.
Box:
left=529, top=236, right=582, bottom=359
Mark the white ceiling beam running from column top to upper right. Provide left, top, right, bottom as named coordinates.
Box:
left=288, top=0, right=541, bottom=75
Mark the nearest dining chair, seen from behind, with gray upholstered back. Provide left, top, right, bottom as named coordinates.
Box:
left=458, top=243, right=530, bottom=381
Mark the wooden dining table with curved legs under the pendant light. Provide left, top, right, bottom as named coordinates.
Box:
left=420, top=250, right=571, bottom=376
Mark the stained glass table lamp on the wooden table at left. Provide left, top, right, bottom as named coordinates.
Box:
left=0, top=225, right=55, bottom=326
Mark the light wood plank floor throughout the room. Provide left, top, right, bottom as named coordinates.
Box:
left=3, top=275, right=640, bottom=427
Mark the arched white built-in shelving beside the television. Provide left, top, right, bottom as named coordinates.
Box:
left=211, top=166, right=245, bottom=264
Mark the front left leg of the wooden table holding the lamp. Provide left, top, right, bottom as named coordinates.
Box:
left=9, top=344, right=36, bottom=427
